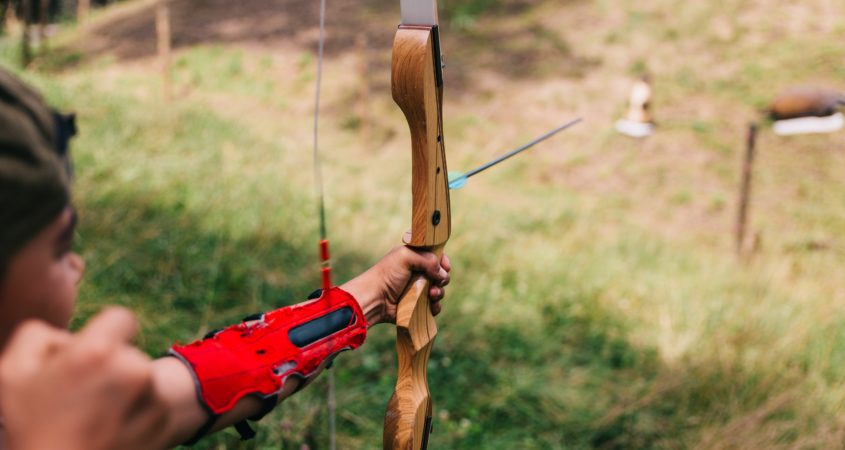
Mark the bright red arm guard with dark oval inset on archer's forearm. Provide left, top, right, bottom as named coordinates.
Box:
left=169, top=288, right=367, bottom=415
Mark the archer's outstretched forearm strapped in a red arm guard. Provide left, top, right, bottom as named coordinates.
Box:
left=154, top=288, right=372, bottom=445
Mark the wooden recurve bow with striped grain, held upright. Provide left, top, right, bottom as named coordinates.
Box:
left=384, top=0, right=451, bottom=450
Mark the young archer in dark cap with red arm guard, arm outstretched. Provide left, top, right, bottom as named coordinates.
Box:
left=0, top=70, right=451, bottom=450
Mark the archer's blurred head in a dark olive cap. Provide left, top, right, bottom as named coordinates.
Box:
left=0, top=70, right=84, bottom=349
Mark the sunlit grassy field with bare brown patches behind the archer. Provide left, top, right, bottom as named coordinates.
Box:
left=0, top=0, right=845, bottom=449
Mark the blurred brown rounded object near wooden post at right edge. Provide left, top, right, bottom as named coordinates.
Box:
left=769, top=86, right=845, bottom=120
